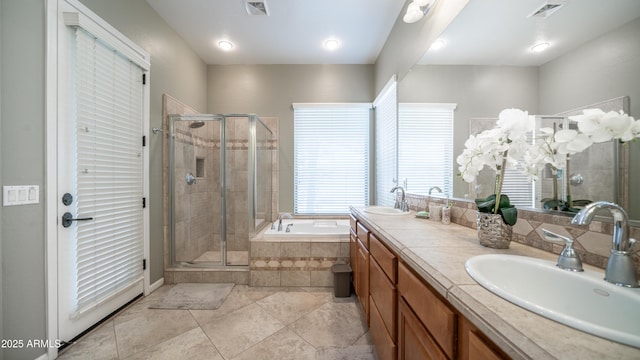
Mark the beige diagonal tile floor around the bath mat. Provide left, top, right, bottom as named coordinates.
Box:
left=59, top=285, right=376, bottom=360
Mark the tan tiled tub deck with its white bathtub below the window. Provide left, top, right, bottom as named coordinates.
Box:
left=249, top=219, right=349, bottom=287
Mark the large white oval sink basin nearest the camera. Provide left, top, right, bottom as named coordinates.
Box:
left=465, top=254, right=640, bottom=348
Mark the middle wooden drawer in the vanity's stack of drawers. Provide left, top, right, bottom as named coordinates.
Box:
left=369, top=258, right=398, bottom=341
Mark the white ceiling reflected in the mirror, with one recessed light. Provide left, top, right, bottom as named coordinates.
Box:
left=419, top=0, right=640, bottom=66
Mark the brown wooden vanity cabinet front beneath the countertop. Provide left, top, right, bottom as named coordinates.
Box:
left=349, top=212, right=509, bottom=360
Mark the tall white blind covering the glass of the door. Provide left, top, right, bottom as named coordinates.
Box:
left=75, top=28, right=144, bottom=312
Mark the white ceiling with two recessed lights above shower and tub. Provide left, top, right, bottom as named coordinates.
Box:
left=147, top=0, right=404, bottom=64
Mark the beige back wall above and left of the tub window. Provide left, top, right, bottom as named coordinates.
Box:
left=207, top=65, right=374, bottom=212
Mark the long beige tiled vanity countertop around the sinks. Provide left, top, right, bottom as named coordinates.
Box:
left=351, top=208, right=640, bottom=359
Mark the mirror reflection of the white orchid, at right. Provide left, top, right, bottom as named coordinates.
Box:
left=523, top=109, right=640, bottom=211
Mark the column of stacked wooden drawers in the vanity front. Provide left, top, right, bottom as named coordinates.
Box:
left=369, top=234, right=398, bottom=360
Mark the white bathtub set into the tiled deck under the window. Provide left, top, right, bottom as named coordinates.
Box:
left=263, top=219, right=350, bottom=237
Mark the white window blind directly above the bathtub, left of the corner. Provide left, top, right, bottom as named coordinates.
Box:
left=294, top=104, right=371, bottom=214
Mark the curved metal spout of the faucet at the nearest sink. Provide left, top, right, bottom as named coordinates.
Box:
left=571, top=201, right=638, bottom=287
